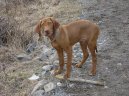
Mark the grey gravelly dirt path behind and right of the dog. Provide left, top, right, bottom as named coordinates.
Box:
left=51, top=0, right=129, bottom=96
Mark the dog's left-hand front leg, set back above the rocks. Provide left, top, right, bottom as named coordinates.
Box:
left=54, top=48, right=64, bottom=75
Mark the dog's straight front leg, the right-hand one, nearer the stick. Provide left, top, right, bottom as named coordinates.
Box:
left=64, top=47, right=72, bottom=79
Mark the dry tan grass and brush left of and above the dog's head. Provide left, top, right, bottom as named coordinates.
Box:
left=0, top=0, right=79, bottom=96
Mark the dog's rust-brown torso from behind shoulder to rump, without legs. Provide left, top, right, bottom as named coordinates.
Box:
left=63, top=20, right=99, bottom=45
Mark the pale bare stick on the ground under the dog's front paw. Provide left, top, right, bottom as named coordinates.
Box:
left=55, top=75, right=104, bottom=86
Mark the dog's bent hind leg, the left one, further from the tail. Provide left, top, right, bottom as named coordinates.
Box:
left=76, top=41, right=89, bottom=68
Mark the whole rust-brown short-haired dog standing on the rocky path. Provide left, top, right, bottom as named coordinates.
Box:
left=36, top=17, right=99, bottom=78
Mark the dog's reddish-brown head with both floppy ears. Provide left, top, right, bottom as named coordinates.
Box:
left=35, top=17, right=60, bottom=38
